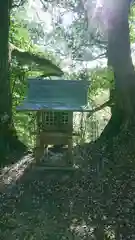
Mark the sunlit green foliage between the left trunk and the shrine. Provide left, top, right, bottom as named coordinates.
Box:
left=10, top=17, right=50, bottom=147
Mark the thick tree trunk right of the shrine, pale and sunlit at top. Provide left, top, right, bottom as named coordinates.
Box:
left=102, top=0, right=135, bottom=137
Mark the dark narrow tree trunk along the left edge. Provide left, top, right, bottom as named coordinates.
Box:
left=0, top=0, right=11, bottom=155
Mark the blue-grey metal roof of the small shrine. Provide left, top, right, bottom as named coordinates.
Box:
left=17, top=79, right=89, bottom=111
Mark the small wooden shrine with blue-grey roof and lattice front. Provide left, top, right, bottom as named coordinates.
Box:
left=17, top=78, right=89, bottom=163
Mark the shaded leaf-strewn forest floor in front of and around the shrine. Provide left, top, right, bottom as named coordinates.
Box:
left=0, top=136, right=135, bottom=240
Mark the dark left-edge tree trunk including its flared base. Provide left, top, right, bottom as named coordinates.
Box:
left=0, top=0, right=27, bottom=161
